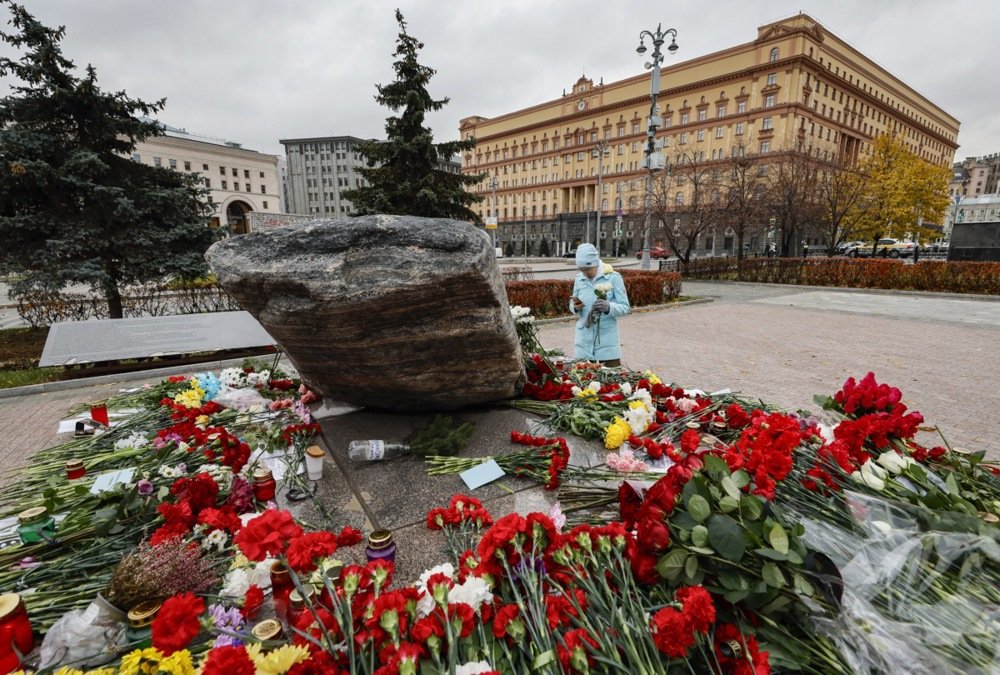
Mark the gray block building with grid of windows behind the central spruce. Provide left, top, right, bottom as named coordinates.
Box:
left=280, top=136, right=462, bottom=218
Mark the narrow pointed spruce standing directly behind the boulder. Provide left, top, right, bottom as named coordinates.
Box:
left=344, top=9, right=485, bottom=223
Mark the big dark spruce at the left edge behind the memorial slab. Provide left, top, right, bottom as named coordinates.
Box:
left=0, top=0, right=215, bottom=318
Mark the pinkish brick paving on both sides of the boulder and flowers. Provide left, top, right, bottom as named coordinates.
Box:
left=0, top=283, right=1000, bottom=484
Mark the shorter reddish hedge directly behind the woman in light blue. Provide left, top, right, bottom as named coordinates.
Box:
left=507, top=270, right=681, bottom=319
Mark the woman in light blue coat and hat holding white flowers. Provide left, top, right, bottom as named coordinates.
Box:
left=569, top=244, right=632, bottom=366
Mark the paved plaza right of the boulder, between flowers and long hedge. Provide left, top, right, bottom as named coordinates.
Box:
left=540, top=281, right=1000, bottom=461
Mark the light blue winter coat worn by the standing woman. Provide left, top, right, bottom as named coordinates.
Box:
left=569, top=272, right=632, bottom=361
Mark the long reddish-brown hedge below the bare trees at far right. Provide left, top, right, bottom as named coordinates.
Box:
left=684, top=258, right=1000, bottom=295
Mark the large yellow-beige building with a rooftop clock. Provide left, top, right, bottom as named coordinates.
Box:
left=459, top=14, right=959, bottom=255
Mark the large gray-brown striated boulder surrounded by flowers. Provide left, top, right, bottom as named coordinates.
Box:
left=206, top=215, right=524, bottom=411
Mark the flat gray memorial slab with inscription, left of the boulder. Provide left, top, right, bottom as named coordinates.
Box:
left=38, top=312, right=275, bottom=366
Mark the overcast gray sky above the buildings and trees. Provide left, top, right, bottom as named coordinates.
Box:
left=0, top=0, right=1000, bottom=158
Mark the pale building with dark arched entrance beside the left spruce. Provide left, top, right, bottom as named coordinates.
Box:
left=132, top=126, right=284, bottom=234
